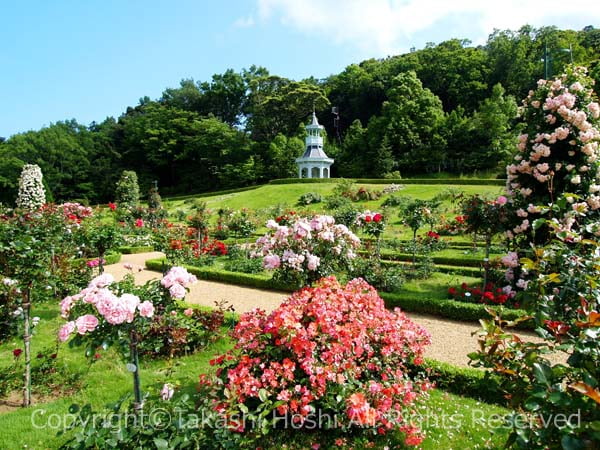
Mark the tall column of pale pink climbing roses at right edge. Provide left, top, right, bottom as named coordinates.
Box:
left=507, top=67, right=600, bottom=237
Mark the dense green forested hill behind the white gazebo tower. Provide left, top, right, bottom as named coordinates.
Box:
left=0, top=26, right=600, bottom=204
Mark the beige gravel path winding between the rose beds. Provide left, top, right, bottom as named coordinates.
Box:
left=105, top=252, right=562, bottom=367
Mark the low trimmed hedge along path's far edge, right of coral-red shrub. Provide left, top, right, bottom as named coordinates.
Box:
left=379, top=292, right=534, bottom=330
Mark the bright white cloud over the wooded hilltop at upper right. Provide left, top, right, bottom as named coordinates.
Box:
left=257, top=0, right=600, bottom=56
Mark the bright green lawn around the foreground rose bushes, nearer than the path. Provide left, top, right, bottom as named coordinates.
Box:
left=0, top=305, right=507, bottom=449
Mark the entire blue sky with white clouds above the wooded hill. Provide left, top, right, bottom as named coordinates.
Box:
left=0, top=0, right=600, bottom=137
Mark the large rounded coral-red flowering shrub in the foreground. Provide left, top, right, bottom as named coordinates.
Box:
left=201, top=277, right=430, bottom=445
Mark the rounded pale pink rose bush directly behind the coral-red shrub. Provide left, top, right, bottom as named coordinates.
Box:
left=252, top=216, right=360, bottom=286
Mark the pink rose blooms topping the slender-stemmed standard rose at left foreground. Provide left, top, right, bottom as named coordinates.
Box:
left=58, top=273, right=154, bottom=342
